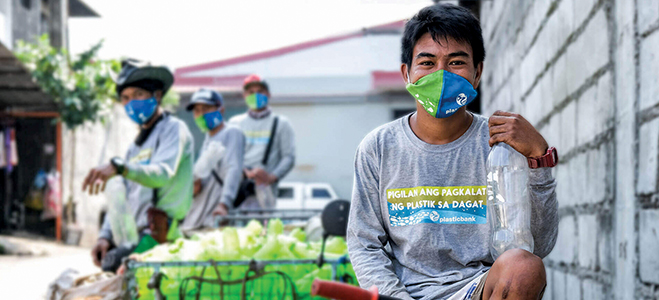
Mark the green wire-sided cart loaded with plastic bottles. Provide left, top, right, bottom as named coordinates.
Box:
left=125, top=257, right=357, bottom=300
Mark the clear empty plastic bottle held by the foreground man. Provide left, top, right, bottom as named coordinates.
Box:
left=487, top=143, right=533, bottom=260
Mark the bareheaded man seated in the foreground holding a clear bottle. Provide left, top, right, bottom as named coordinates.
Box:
left=347, top=4, right=558, bottom=300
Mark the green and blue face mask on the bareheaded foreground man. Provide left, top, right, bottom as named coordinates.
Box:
left=405, top=70, right=478, bottom=118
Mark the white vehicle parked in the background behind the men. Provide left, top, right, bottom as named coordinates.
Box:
left=276, top=182, right=338, bottom=209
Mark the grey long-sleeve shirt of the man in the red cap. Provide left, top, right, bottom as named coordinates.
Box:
left=229, top=113, right=295, bottom=179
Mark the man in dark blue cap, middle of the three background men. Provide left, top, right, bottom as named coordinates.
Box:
left=181, top=89, right=245, bottom=230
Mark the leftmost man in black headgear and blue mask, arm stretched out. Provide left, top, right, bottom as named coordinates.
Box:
left=82, top=60, right=194, bottom=269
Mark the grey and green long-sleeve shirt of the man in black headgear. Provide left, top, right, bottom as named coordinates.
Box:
left=99, top=114, right=194, bottom=240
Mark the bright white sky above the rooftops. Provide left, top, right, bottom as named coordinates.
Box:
left=69, top=0, right=433, bottom=69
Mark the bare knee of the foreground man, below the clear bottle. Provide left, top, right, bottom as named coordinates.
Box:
left=490, top=249, right=547, bottom=299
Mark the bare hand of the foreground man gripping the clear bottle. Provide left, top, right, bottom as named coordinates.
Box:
left=488, top=110, right=549, bottom=157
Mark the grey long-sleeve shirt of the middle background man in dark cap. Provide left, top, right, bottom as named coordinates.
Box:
left=181, top=124, right=245, bottom=230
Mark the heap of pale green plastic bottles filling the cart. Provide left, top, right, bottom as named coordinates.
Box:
left=135, top=219, right=355, bottom=299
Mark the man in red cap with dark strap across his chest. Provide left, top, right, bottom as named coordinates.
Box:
left=230, top=75, right=295, bottom=208
